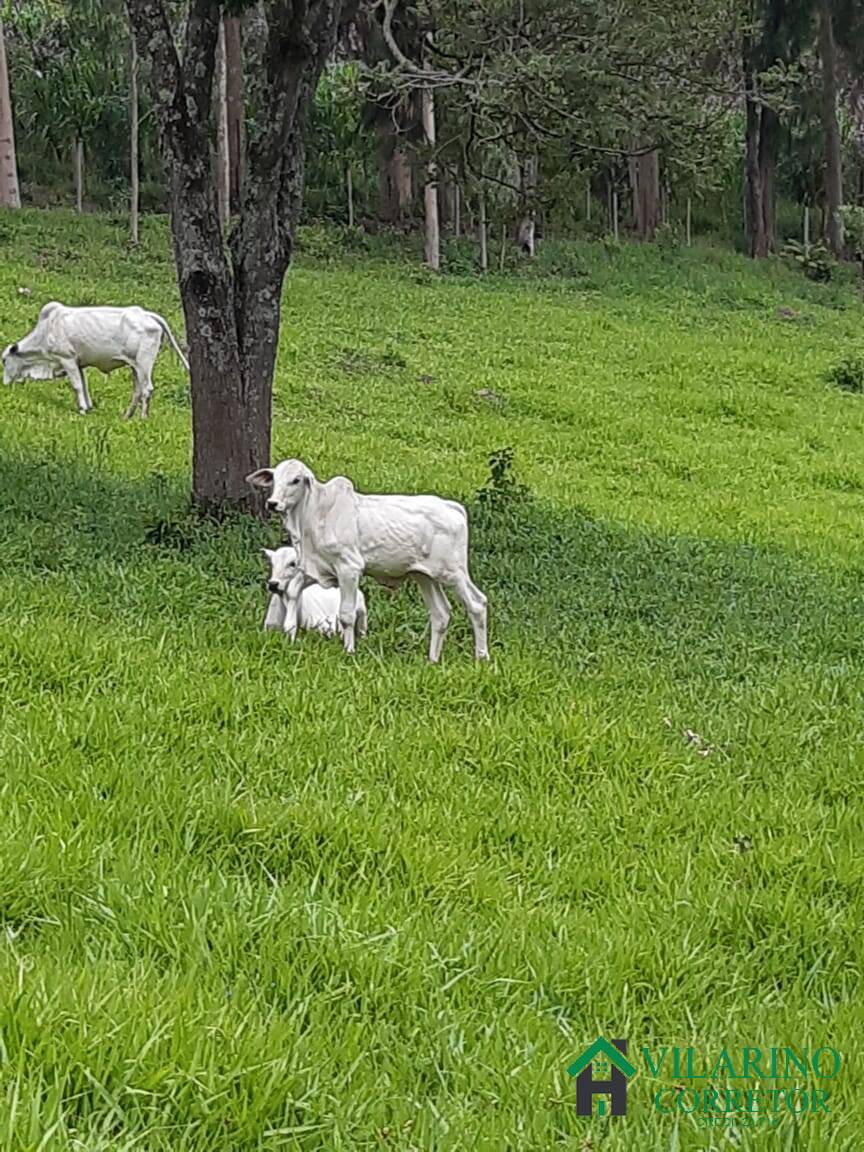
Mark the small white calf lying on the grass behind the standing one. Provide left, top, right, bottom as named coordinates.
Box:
left=263, top=547, right=367, bottom=641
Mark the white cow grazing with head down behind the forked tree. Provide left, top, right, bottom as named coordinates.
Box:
left=3, top=301, right=189, bottom=419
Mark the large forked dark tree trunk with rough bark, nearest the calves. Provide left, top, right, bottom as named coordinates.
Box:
left=127, top=0, right=342, bottom=511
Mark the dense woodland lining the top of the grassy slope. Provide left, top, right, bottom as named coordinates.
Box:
left=6, top=0, right=864, bottom=276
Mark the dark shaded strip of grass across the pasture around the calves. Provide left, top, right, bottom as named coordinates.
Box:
left=0, top=441, right=864, bottom=675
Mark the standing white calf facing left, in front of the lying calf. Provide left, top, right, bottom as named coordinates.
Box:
left=247, top=460, right=488, bottom=662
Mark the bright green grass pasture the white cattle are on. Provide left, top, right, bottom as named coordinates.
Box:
left=0, top=212, right=864, bottom=1152
